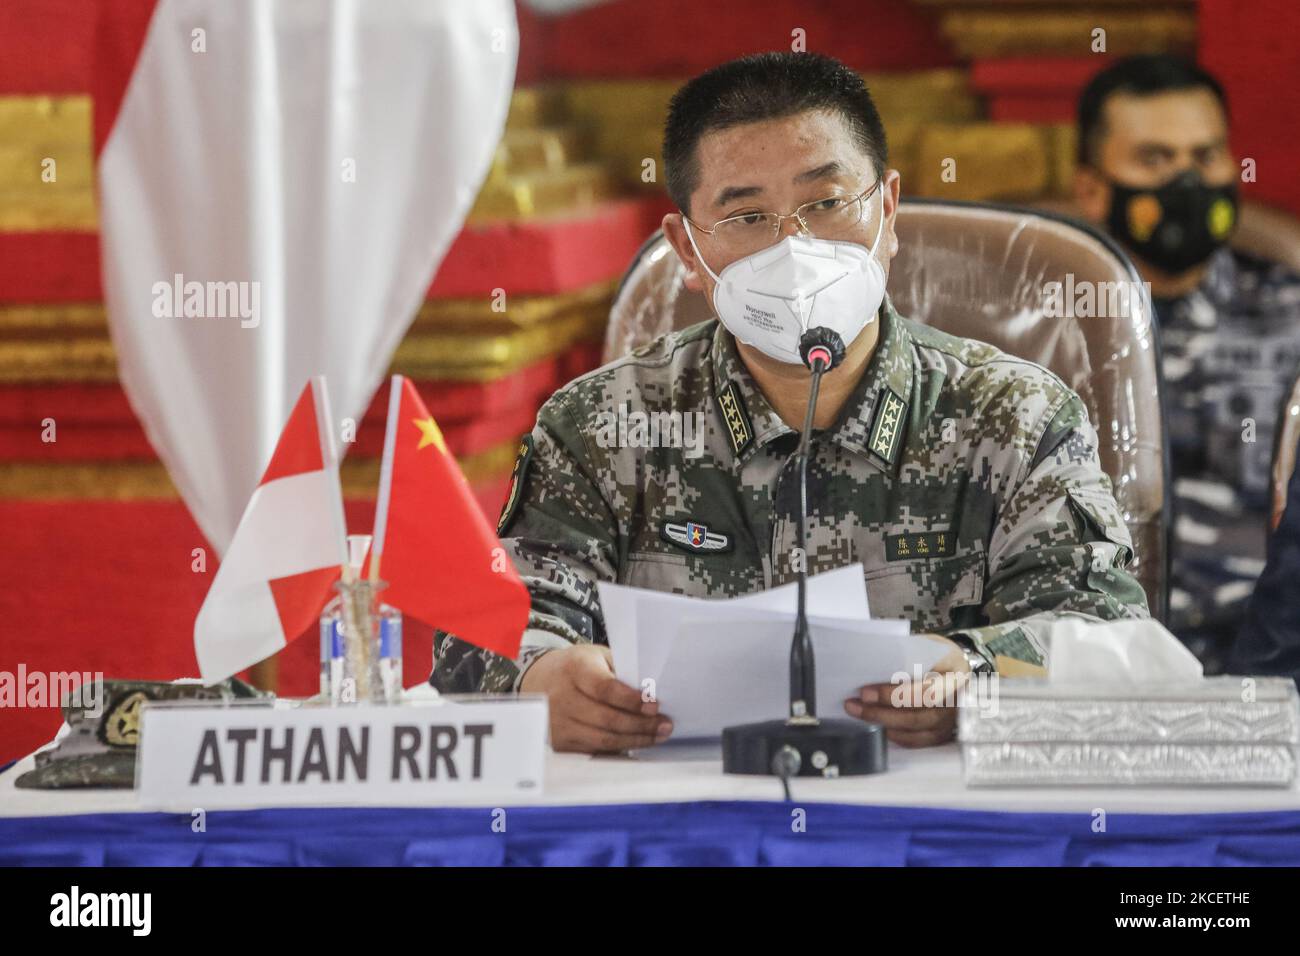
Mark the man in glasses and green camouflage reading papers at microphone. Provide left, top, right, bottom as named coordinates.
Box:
left=432, top=55, right=1147, bottom=750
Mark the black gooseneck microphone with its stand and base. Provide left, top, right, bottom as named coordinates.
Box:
left=723, top=328, right=887, bottom=785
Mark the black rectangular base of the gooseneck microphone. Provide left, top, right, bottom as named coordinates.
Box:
left=723, top=719, right=888, bottom=777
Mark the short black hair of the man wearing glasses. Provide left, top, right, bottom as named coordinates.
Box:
left=663, top=52, right=889, bottom=212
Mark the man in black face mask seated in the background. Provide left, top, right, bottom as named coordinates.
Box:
left=1074, top=55, right=1300, bottom=672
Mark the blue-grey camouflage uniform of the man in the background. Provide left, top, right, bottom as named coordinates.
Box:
left=1153, top=248, right=1300, bottom=674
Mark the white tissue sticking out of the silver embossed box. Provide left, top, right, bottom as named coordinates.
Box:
left=1048, top=618, right=1204, bottom=684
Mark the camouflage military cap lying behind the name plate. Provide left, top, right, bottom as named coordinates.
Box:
left=14, top=678, right=272, bottom=790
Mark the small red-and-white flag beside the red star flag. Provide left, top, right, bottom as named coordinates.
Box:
left=194, top=380, right=342, bottom=683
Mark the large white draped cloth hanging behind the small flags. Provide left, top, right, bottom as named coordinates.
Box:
left=99, top=0, right=519, bottom=553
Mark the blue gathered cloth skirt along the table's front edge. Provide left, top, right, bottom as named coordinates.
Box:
left=0, top=801, right=1300, bottom=866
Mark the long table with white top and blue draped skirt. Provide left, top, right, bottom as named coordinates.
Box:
left=0, top=744, right=1300, bottom=866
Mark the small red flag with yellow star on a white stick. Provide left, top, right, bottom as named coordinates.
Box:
left=372, top=376, right=529, bottom=658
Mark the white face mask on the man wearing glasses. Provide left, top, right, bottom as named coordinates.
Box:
left=686, top=186, right=885, bottom=365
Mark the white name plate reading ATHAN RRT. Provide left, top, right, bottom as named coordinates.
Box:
left=135, top=696, right=547, bottom=812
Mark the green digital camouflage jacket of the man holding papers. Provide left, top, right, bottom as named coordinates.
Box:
left=430, top=302, right=1147, bottom=692
